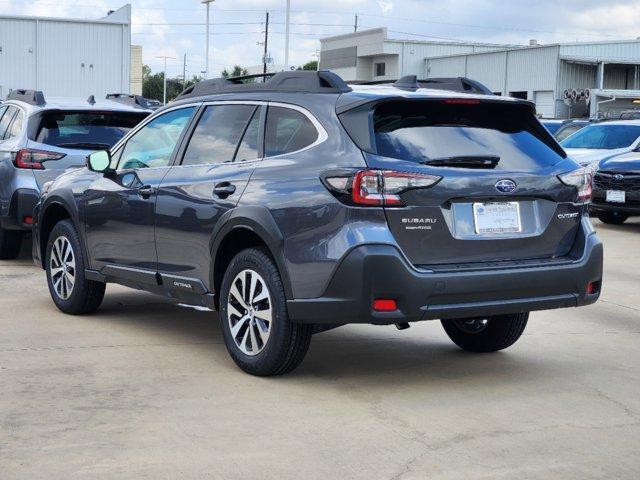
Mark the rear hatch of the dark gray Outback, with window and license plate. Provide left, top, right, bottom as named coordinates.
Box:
left=342, top=98, right=584, bottom=269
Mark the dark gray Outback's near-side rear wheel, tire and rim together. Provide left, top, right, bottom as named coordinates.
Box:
left=220, top=248, right=312, bottom=376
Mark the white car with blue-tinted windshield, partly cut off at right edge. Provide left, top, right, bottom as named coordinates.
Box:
left=560, top=120, right=640, bottom=168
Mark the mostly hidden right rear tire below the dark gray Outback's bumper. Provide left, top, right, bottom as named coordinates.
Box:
left=442, top=313, right=529, bottom=353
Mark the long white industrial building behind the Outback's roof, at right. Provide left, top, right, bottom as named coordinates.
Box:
left=321, top=28, right=640, bottom=118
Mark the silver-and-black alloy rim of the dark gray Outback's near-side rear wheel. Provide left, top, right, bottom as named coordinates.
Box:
left=227, top=269, right=273, bottom=356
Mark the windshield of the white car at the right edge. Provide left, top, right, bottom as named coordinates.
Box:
left=561, top=124, right=640, bottom=150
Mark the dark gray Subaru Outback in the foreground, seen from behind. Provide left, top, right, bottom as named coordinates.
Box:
left=33, top=71, right=602, bottom=375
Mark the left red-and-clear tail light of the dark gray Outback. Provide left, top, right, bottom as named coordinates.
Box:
left=322, top=170, right=442, bottom=207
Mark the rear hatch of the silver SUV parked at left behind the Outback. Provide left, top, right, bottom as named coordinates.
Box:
left=25, top=110, right=149, bottom=188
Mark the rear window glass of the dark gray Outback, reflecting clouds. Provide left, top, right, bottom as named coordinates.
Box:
left=373, top=101, right=564, bottom=170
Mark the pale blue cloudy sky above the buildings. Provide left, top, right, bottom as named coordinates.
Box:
left=0, top=0, right=640, bottom=76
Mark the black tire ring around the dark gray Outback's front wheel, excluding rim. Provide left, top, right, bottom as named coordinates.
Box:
left=45, top=220, right=88, bottom=313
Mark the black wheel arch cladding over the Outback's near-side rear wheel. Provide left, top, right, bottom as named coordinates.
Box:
left=209, top=207, right=293, bottom=308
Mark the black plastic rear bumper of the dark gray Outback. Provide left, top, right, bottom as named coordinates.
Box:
left=288, top=219, right=603, bottom=325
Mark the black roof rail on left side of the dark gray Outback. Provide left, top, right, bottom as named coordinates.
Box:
left=176, top=70, right=351, bottom=100
